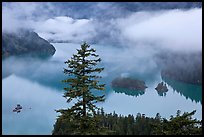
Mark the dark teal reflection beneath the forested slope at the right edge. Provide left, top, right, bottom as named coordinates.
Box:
left=162, top=77, right=202, bottom=104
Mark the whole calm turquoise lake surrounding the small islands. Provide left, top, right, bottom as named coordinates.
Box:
left=2, top=43, right=202, bottom=134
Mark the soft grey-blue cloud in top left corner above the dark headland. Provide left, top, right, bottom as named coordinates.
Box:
left=2, top=2, right=61, bottom=33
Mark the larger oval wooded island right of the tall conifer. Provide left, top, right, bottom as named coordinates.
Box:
left=111, top=77, right=147, bottom=91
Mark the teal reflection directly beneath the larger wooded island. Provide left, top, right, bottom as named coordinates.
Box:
left=113, top=87, right=145, bottom=97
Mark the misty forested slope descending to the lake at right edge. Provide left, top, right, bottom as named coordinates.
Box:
left=156, top=52, right=202, bottom=85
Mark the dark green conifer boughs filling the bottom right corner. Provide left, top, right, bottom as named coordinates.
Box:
left=153, top=110, right=202, bottom=135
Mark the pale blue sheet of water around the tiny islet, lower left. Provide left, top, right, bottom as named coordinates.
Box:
left=2, top=75, right=69, bottom=135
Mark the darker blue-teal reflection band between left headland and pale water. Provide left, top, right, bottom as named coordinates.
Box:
left=2, top=56, right=65, bottom=90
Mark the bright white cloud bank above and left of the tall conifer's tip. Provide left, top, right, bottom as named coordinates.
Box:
left=35, top=16, right=95, bottom=42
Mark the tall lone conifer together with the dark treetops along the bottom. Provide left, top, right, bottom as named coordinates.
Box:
left=52, top=43, right=202, bottom=135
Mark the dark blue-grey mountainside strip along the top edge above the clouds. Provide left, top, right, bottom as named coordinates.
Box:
left=52, top=2, right=202, bottom=20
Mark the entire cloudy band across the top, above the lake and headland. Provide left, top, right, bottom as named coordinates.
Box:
left=2, top=2, right=202, bottom=51
